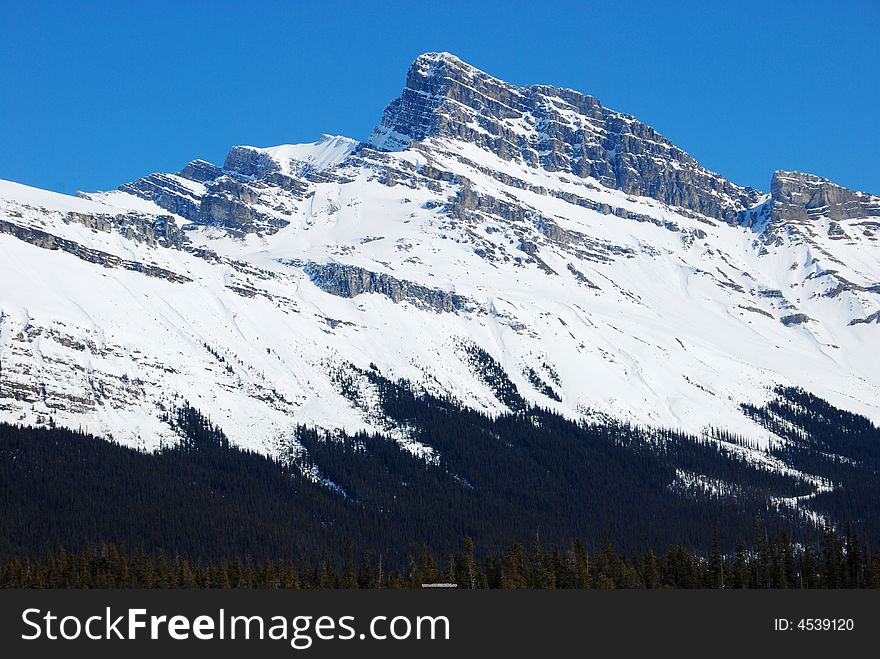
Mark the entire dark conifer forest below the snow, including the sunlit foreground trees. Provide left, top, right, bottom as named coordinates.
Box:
left=0, top=374, right=880, bottom=588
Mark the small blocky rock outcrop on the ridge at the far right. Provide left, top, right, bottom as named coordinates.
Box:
left=770, top=171, right=880, bottom=221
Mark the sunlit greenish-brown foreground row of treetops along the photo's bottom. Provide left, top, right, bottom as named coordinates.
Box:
left=0, top=527, right=880, bottom=589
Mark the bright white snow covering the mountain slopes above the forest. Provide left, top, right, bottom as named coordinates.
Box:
left=0, top=125, right=880, bottom=459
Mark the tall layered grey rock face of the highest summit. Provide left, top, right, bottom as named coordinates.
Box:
left=370, top=53, right=760, bottom=222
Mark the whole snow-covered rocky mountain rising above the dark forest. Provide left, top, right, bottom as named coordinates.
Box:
left=0, top=53, right=880, bottom=456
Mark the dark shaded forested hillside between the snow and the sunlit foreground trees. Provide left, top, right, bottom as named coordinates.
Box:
left=0, top=382, right=880, bottom=576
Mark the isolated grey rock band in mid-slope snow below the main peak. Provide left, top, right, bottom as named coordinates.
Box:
left=303, top=263, right=469, bottom=312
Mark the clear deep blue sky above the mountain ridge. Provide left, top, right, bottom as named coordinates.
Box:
left=0, top=0, right=880, bottom=193
